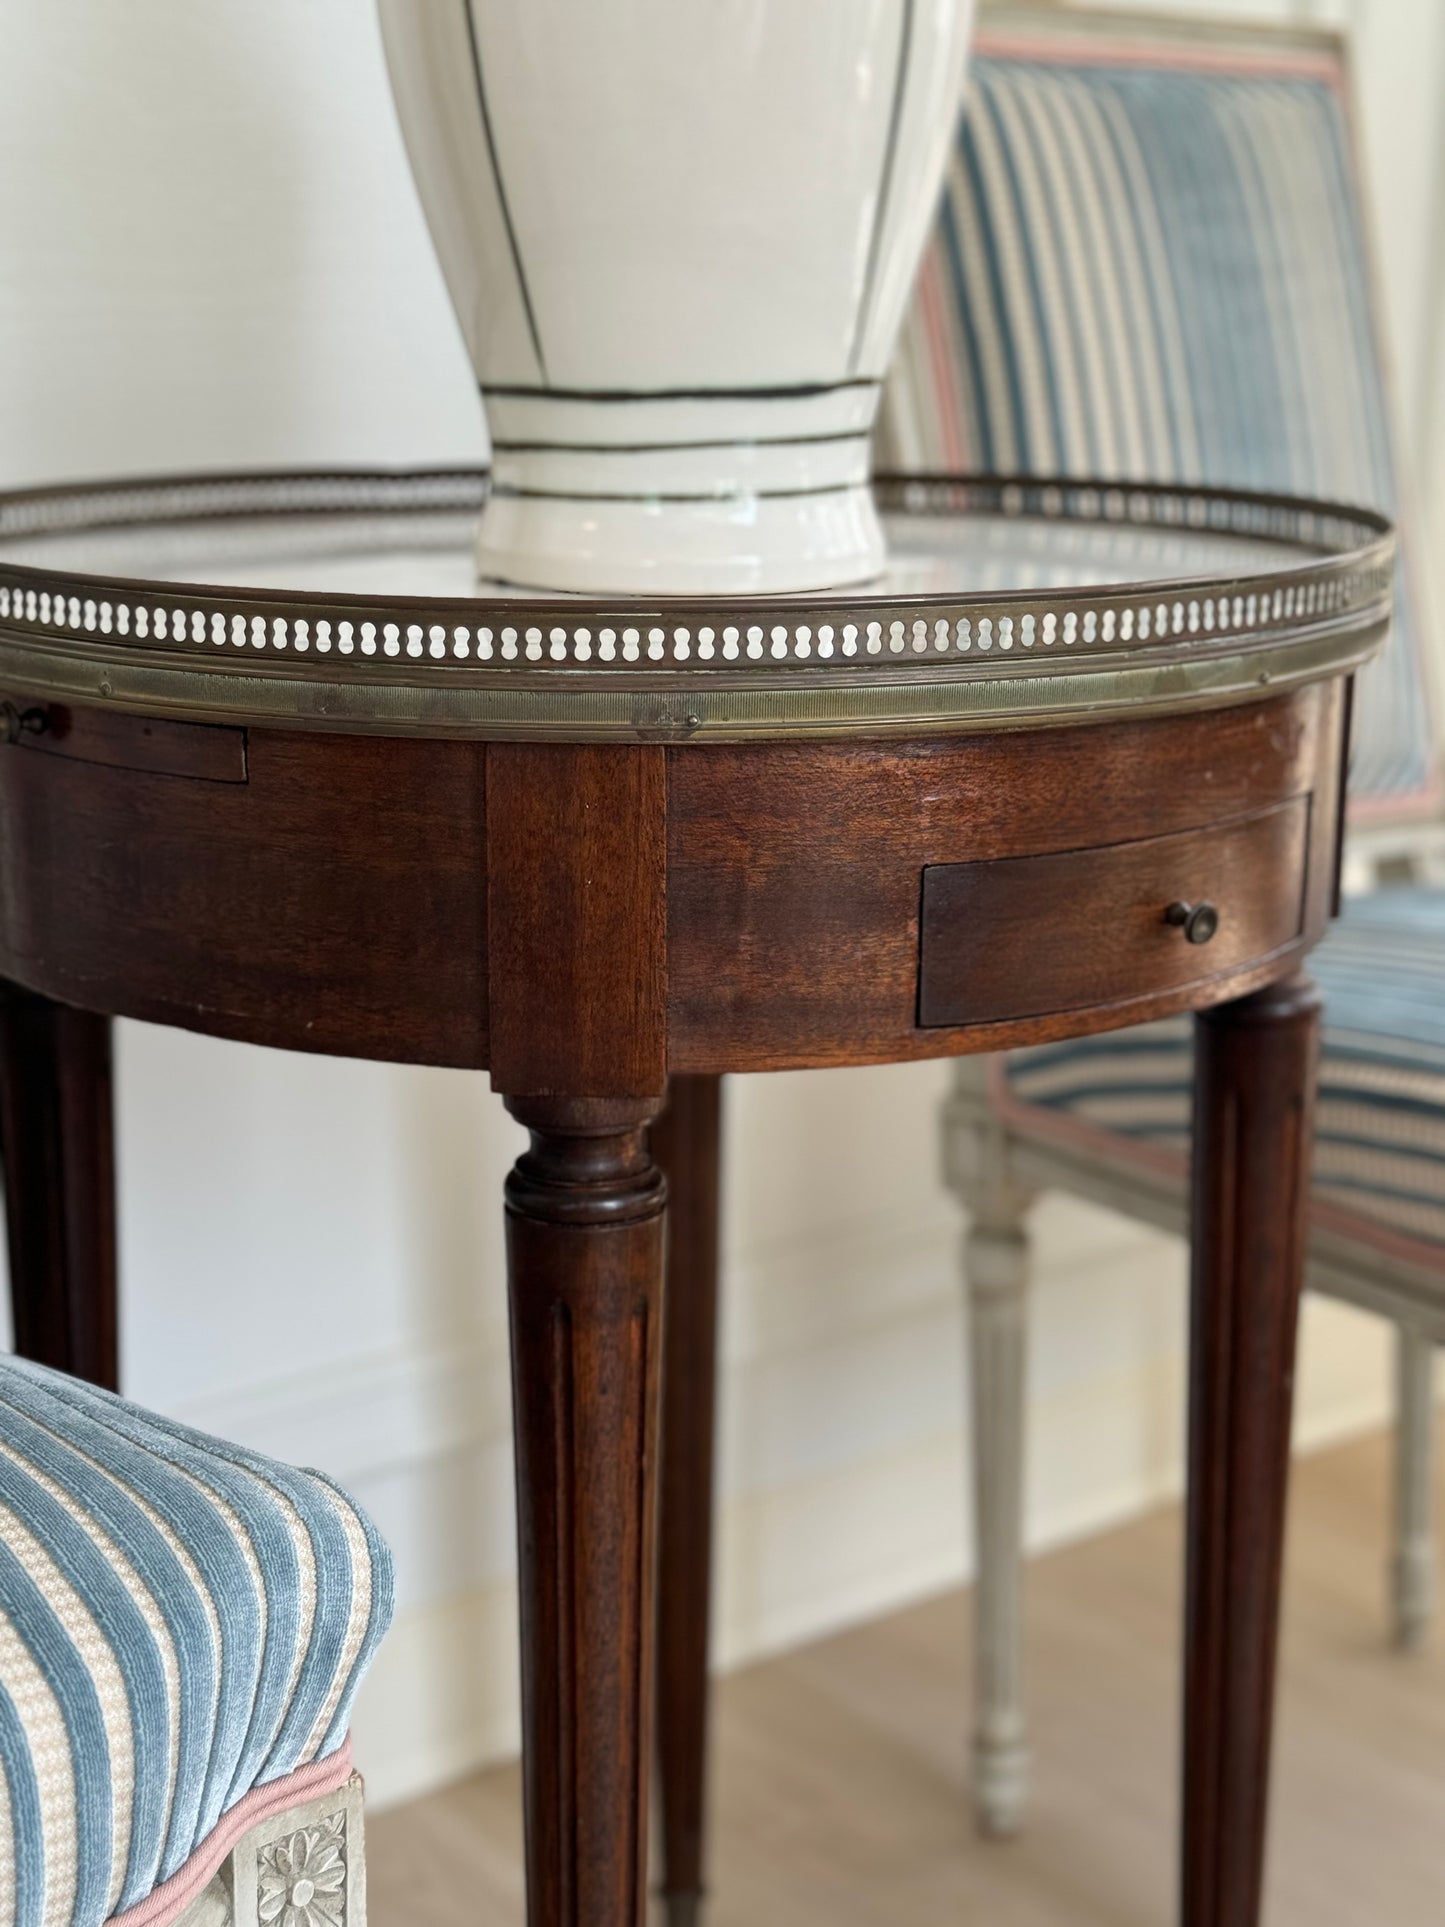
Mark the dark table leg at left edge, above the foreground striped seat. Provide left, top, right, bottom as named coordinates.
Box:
left=0, top=985, right=119, bottom=1391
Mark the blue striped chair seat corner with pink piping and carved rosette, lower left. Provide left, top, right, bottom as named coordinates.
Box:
left=0, top=1359, right=391, bottom=1927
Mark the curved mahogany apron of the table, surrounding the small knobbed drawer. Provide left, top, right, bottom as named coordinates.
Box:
left=0, top=688, right=1341, bottom=1095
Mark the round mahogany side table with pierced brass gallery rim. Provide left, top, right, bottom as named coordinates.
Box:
left=0, top=472, right=1393, bottom=1927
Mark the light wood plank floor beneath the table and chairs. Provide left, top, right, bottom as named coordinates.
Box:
left=368, top=1439, right=1445, bottom=1927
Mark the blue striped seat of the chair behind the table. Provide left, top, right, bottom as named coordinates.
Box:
left=1004, top=888, right=1445, bottom=1264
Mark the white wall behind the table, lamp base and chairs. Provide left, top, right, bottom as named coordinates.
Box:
left=0, top=0, right=1445, bottom=1798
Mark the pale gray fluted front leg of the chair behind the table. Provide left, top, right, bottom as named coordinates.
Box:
left=942, top=1058, right=1033, bottom=1836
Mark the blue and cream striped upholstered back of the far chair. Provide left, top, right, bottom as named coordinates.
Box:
left=879, top=6, right=1435, bottom=817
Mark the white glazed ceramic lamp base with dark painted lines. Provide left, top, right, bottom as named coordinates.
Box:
left=380, top=0, right=971, bottom=595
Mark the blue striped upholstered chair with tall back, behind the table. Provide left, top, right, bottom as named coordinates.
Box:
left=879, top=6, right=1445, bottom=1833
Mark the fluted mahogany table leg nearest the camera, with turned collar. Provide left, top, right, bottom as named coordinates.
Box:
left=507, top=1098, right=667, bottom=1927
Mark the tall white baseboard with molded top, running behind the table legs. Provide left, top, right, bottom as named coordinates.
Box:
left=166, top=1201, right=1387, bottom=1808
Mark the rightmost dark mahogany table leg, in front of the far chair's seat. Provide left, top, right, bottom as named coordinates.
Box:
left=1181, top=977, right=1320, bottom=1927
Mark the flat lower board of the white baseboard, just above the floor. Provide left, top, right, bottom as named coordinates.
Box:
left=355, top=1308, right=1383, bottom=1809
